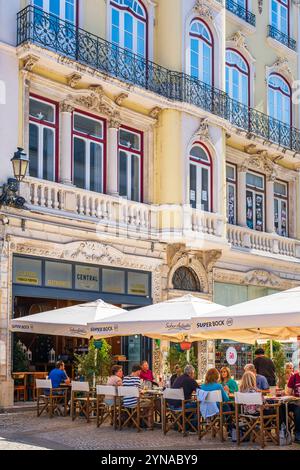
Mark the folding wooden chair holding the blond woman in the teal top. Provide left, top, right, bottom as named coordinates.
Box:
left=197, top=390, right=235, bottom=442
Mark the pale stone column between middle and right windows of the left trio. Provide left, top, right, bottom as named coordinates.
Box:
left=106, top=119, right=121, bottom=196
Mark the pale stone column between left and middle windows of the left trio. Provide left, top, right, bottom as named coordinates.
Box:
left=59, top=101, right=74, bottom=185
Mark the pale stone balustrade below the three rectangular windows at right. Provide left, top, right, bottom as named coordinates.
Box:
left=227, top=225, right=300, bottom=258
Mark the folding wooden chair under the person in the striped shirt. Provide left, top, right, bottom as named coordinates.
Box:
left=117, top=387, right=154, bottom=432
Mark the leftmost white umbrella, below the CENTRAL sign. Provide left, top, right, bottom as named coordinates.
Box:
left=11, top=299, right=125, bottom=338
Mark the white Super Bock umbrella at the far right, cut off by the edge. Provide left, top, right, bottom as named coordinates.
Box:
left=192, top=287, right=300, bottom=342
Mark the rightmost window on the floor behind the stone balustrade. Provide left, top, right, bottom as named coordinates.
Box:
left=274, top=181, right=289, bottom=237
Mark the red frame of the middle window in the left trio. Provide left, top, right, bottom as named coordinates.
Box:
left=71, top=108, right=107, bottom=194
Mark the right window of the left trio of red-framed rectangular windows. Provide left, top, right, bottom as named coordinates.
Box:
left=119, top=127, right=143, bottom=202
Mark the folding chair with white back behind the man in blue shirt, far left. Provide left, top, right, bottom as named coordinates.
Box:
left=36, top=379, right=67, bottom=418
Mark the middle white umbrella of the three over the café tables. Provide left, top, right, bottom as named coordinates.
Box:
left=89, top=295, right=224, bottom=341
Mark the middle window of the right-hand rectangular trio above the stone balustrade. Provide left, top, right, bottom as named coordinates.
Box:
left=246, top=173, right=265, bottom=232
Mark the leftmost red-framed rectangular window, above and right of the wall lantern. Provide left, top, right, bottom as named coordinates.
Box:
left=29, top=96, right=58, bottom=181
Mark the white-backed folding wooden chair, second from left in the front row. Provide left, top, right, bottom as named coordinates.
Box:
left=71, top=381, right=97, bottom=423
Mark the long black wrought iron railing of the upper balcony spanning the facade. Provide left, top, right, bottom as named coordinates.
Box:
left=17, top=6, right=300, bottom=152
